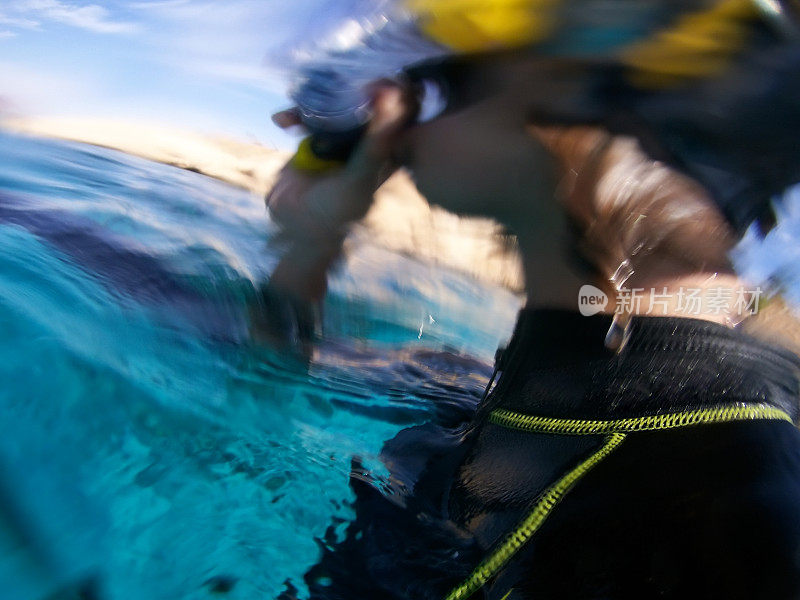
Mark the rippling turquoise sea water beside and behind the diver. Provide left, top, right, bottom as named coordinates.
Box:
left=0, top=133, right=519, bottom=600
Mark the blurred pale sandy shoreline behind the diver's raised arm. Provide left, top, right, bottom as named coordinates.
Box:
left=2, top=117, right=522, bottom=291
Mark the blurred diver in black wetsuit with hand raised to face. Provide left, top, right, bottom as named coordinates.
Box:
left=260, top=2, right=800, bottom=600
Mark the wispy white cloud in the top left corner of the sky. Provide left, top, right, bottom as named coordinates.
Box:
left=7, top=0, right=138, bottom=33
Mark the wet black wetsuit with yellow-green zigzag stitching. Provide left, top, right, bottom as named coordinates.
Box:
left=285, top=311, right=800, bottom=600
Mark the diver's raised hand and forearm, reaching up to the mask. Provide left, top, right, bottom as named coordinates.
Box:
left=251, top=84, right=413, bottom=356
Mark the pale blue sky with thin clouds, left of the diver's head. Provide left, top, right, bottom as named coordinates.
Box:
left=0, top=0, right=353, bottom=148
